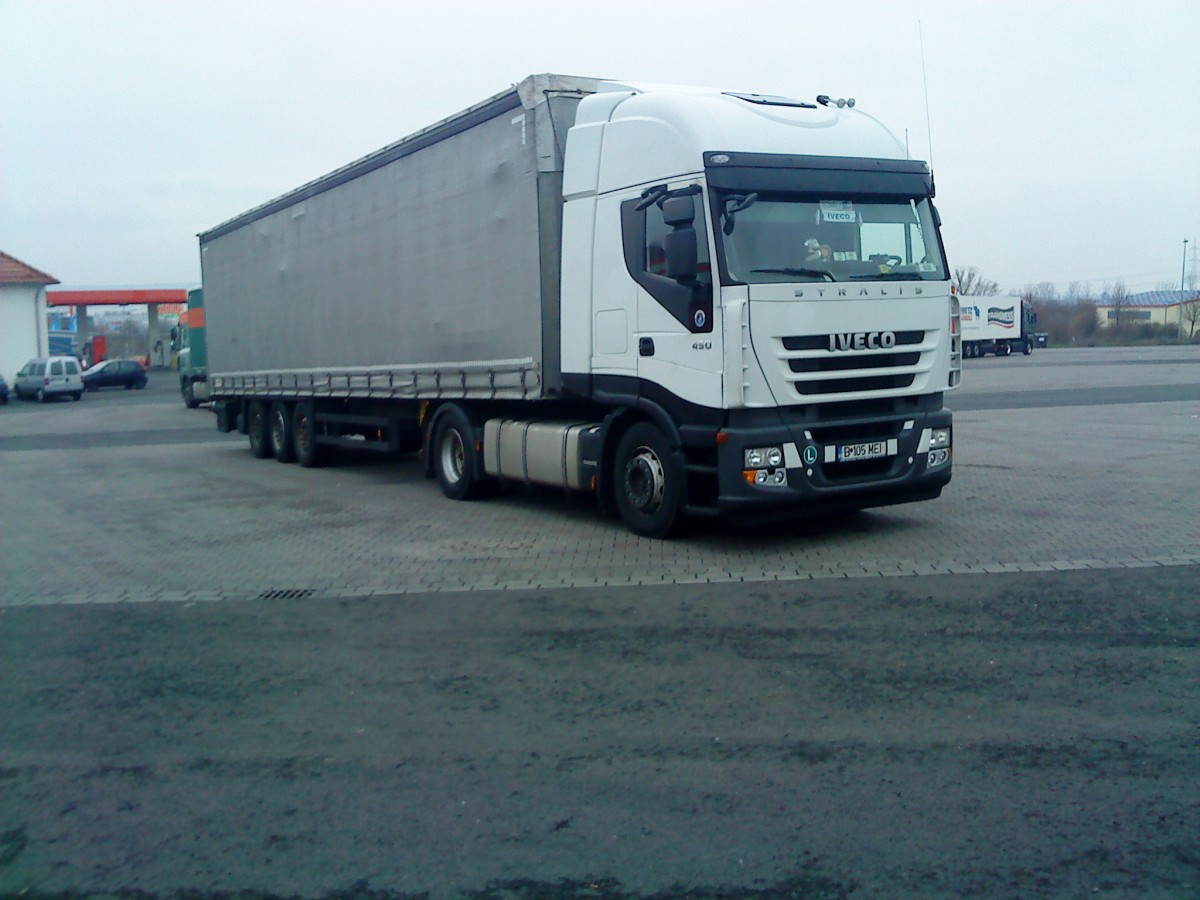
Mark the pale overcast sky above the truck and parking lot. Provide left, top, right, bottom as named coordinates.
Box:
left=0, top=0, right=1200, bottom=292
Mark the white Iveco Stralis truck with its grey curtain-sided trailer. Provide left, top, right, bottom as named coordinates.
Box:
left=199, top=74, right=961, bottom=536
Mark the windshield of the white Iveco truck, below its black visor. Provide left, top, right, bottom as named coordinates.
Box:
left=716, top=193, right=947, bottom=284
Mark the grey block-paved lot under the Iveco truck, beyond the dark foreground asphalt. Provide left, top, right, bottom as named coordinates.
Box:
left=0, top=355, right=1200, bottom=606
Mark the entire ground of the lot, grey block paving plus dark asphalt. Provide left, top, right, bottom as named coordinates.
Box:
left=0, top=348, right=1200, bottom=900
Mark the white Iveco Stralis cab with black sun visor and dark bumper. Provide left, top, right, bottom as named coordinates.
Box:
left=562, top=90, right=961, bottom=528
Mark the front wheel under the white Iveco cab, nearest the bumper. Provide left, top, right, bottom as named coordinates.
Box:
left=612, top=422, right=684, bottom=538
